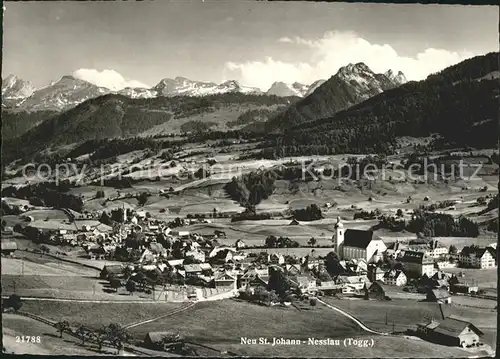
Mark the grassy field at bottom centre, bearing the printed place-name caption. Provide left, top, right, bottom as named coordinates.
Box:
left=124, top=300, right=472, bottom=358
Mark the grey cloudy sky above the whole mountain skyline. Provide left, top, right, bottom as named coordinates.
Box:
left=2, top=0, right=499, bottom=90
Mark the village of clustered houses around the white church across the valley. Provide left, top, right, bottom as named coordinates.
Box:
left=2, top=201, right=497, bottom=356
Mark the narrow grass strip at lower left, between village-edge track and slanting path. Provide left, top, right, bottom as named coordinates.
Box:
left=22, top=301, right=186, bottom=332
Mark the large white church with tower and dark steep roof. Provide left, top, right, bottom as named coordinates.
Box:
left=332, top=217, right=387, bottom=262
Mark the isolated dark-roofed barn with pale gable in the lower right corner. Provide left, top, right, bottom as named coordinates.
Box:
left=417, top=318, right=483, bottom=347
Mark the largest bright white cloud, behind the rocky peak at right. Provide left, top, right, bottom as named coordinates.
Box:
left=225, top=32, right=474, bottom=89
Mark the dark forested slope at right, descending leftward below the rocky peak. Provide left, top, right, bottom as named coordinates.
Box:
left=262, top=52, right=500, bottom=158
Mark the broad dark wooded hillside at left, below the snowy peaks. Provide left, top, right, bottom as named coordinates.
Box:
left=3, top=92, right=296, bottom=161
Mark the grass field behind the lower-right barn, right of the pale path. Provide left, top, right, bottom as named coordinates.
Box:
left=325, top=297, right=497, bottom=345
